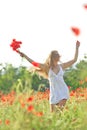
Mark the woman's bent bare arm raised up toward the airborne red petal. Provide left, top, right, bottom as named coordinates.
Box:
left=61, top=41, right=80, bottom=69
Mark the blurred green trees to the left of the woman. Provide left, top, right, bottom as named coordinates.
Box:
left=0, top=64, right=49, bottom=93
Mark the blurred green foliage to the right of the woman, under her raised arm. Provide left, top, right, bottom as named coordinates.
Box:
left=64, top=59, right=87, bottom=89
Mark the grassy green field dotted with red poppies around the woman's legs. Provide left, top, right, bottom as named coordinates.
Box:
left=0, top=82, right=87, bottom=130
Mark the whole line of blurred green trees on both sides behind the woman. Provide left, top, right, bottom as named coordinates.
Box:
left=0, top=57, right=87, bottom=93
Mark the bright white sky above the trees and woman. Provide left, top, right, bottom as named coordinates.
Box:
left=0, top=0, right=87, bottom=67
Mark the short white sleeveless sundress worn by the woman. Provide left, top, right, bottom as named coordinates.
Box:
left=49, top=66, right=69, bottom=104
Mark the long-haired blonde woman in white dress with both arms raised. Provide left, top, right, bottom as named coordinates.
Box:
left=19, top=41, right=80, bottom=112
